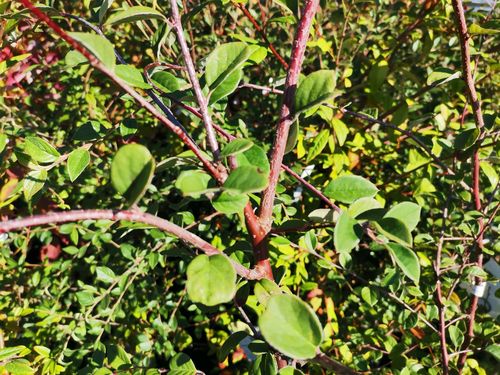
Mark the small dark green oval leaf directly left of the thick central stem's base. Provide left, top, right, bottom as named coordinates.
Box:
left=223, top=166, right=268, bottom=193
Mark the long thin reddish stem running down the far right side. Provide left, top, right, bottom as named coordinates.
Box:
left=452, top=0, right=484, bottom=373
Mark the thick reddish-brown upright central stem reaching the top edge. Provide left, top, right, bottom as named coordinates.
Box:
left=259, top=0, right=319, bottom=232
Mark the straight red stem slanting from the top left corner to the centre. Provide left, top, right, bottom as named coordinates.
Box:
left=20, top=0, right=222, bottom=180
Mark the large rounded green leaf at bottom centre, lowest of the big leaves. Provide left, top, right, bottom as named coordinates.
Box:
left=259, top=294, right=323, bottom=359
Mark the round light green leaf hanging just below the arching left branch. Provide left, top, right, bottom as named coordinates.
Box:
left=186, top=254, right=236, bottom=306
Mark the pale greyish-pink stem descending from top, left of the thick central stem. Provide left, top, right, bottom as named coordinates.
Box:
left=170, top=0, right=220, bottom=160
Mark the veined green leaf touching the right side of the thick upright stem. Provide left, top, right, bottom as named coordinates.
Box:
left=295, top=70, right=335, bottom=114
